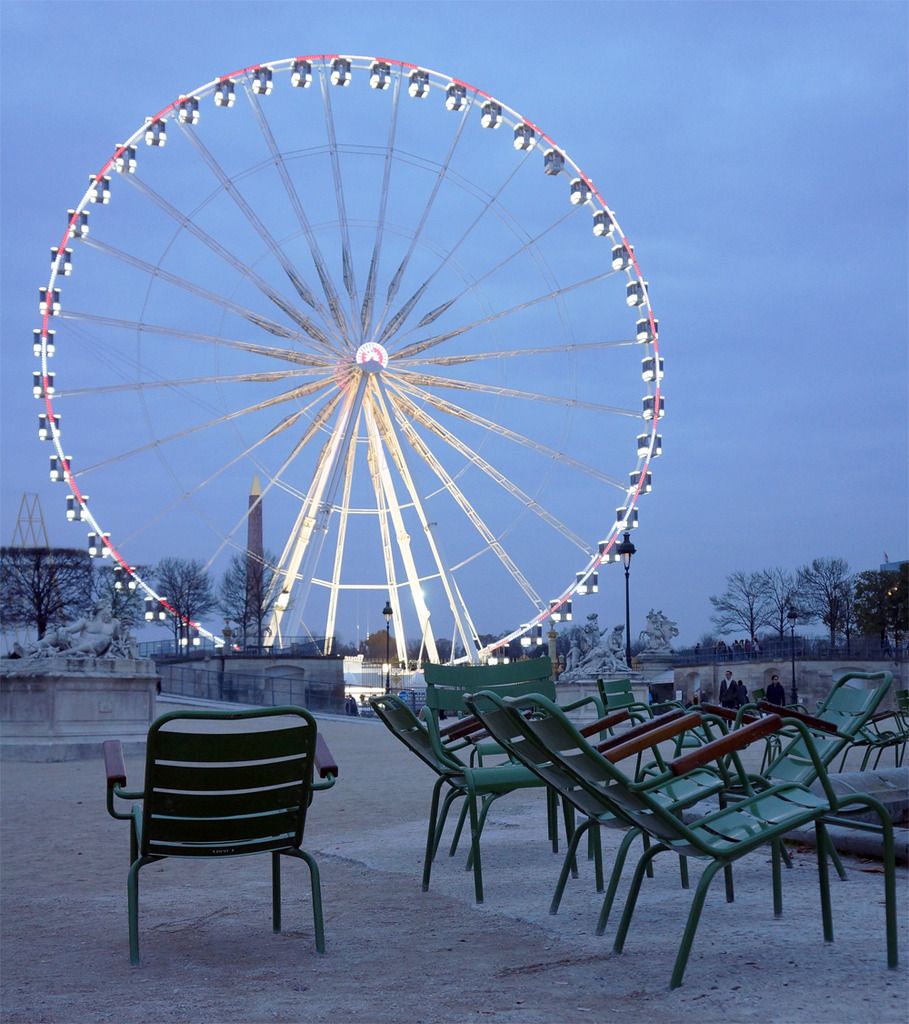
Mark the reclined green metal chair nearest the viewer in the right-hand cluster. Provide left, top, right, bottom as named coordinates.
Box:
left=497, top=699, right=897, bottom=988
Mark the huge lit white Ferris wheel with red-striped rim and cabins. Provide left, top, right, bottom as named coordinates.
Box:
left=33, top=54, right=663, bottom=662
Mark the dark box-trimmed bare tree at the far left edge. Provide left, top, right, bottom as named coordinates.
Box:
left=0, top=547, right=92, bottom=639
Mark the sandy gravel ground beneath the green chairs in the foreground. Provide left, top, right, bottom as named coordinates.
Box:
left=0, top=704, right=909, bottom=1024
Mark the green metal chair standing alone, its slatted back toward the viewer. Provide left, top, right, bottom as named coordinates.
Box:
left=103, top=707, right=338, bottom=965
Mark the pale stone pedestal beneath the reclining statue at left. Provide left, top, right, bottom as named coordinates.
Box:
left=0, top=655, right=158, bottom=761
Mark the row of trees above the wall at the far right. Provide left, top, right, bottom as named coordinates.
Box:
left=710, top=558, right=909, bottom=648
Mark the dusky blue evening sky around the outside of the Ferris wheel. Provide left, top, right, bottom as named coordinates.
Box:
left=0, top=0, right=909, bottom=643
